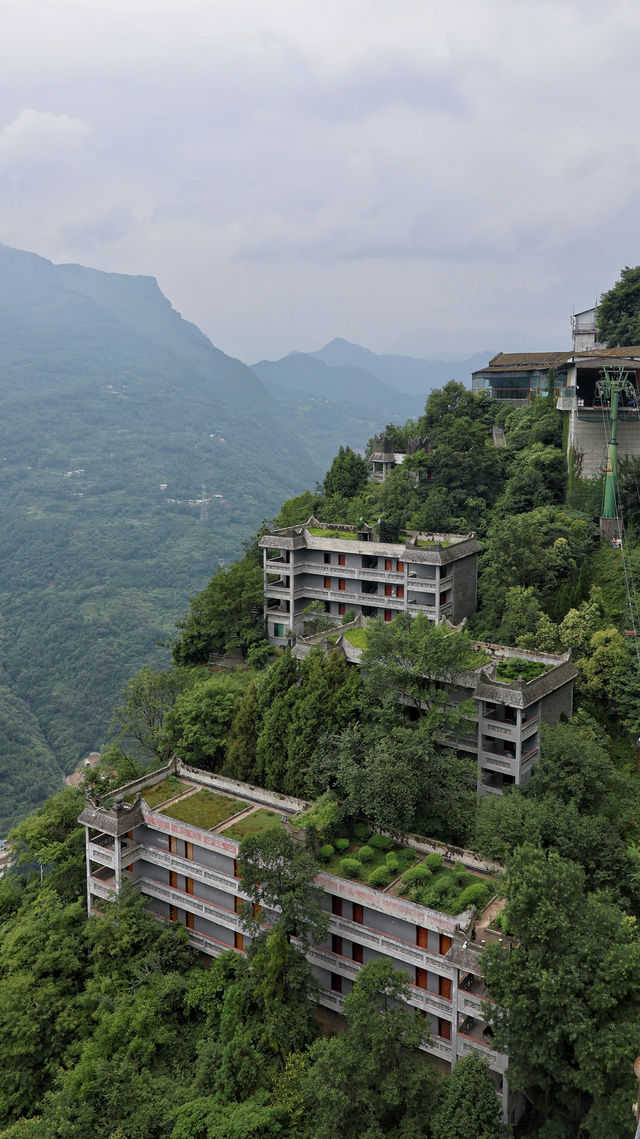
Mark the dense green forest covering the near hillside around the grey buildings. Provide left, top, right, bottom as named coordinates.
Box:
left=0, top=339, right=640, bottom=1139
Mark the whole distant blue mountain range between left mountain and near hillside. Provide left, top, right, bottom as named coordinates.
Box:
left=252, top=337, right=490, bottom=453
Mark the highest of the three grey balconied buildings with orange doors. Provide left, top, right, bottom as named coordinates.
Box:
left=259, top=517, right=481, bottom=645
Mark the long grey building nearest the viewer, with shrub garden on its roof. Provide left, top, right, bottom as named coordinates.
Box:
left=80, top=760, right=518, bottom=1117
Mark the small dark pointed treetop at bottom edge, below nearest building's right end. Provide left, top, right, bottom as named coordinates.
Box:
left=432, top=1052, right=506, bottom=1139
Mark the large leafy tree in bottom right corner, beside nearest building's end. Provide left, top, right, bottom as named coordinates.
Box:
left=483, top=846, right=640, bottom=1139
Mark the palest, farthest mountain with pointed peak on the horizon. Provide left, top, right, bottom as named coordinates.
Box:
left=309, top=336, right=493, bottom=400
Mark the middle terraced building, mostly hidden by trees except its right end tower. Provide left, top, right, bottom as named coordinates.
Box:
left=294, top=620, right=577, bottom=795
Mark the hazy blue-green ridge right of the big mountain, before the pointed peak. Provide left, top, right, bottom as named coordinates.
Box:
left=252, top=352, right=425, bottom=464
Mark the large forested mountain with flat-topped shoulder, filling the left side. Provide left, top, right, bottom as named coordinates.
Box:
left=0, top=246, right=326, bottom=835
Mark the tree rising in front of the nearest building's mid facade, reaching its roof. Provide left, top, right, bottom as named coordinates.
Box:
left=238, top=827, right=328, bottom=948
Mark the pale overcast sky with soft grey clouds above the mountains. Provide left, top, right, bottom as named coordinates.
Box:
left=0, top=0, right=640, bottom=361
